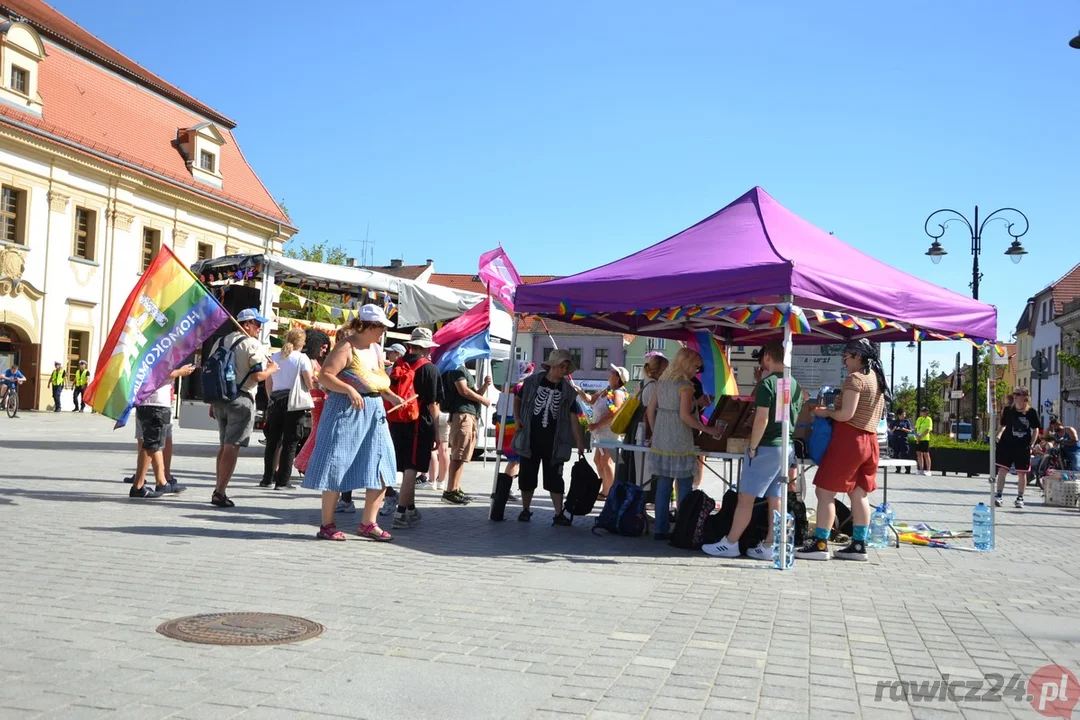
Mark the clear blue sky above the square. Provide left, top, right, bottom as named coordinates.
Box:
left=53, top=0, right=1080, bottom=379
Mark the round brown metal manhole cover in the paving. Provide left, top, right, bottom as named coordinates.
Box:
left=158, top=612, right=324, bottom=646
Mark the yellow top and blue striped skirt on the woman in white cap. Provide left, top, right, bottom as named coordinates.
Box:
left=303, top=350, right=397, bottom=492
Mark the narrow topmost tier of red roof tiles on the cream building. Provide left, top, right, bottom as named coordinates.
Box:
left=0, top=0, right=237, bottom=128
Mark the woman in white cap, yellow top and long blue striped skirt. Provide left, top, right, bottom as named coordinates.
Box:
left=303, top=304, right=402, bottom=542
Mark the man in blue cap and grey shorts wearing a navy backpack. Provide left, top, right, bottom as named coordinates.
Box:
left=202, top=308, right=278, bottom=507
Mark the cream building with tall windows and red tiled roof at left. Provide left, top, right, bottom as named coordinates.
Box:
left=0, top=0, right=296, bottom=409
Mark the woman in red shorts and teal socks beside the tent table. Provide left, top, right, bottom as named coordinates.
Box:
left=795, top=340, right=892, bottom=560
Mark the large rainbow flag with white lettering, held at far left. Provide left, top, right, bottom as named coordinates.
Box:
left=85, top=246, right=229, bottom=427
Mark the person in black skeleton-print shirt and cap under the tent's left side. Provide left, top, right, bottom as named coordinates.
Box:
left=512, top=350, right=585, bottom=526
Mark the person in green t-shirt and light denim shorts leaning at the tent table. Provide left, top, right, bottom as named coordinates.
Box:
left=701, top=340, right=802, bottom=560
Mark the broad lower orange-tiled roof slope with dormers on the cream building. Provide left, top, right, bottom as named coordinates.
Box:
left=0, top=0, right=293, bottom=228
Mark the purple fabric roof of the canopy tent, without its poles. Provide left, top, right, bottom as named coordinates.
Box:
left=514, top=188, right=997, bottom=342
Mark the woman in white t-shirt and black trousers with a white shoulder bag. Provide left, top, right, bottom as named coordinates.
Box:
left=259, top=327, right=314, bottom=490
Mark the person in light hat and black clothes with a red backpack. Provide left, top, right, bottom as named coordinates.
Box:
left=387, top=327, right=443, bottom=530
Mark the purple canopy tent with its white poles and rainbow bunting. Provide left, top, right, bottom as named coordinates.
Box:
left=492, top=188, right=997, bottom=569
